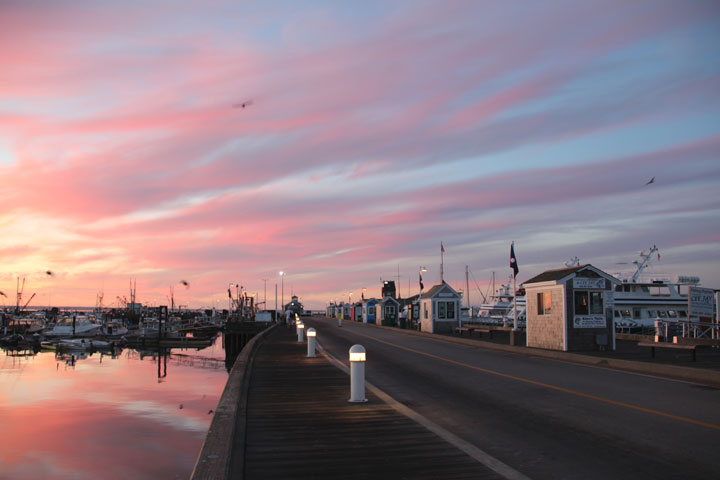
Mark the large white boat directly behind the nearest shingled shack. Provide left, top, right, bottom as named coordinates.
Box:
left=614, top=245, right=700, bottom=330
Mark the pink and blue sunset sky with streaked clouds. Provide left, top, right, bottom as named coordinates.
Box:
left=0, top=0, right=720, bottom=309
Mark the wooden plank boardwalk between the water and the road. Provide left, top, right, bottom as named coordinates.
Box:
left=239, top=327, right=502, bottom=479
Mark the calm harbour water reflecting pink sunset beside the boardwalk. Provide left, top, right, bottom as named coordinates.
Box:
left=0, top=337, right=228, bottom=479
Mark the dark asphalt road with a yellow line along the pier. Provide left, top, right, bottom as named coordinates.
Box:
left=303, top=316, right=720, bottom=480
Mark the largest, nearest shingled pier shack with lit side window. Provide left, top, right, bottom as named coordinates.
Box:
left=522, top=264, right=620, bottom=351
